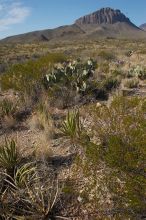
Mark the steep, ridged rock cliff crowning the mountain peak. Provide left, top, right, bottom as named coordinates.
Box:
left=76, top=8, right=131, bottom=25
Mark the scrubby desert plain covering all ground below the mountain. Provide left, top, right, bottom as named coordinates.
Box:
left=0, top=38, right=146, bottom=220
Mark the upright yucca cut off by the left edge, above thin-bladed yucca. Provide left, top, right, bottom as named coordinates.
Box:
left=0, top=140, right=19, bottom=176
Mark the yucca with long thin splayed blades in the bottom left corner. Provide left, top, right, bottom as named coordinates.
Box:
left=2, top=174, right=62, bottom=220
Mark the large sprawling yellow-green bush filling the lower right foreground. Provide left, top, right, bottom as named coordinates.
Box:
left=66, top=96, right=146, bottom=219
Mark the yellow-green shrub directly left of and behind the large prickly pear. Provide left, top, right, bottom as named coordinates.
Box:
left=0, top=54, right=65, bottom=91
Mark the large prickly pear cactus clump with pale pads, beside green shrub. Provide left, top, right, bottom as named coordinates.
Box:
left=43, top=59, right=96, bottom=92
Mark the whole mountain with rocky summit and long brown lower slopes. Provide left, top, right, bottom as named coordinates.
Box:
left=1, top=8, right=146, bottom=43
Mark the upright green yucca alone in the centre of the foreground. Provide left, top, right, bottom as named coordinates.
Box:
left=61, top=111, right=82, bottom=140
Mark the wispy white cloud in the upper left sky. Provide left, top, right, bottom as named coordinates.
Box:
left=0, top=0, right=30, bottom=31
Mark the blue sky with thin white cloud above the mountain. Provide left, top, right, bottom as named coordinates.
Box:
left=0, top=0, right=146, bottom=38
